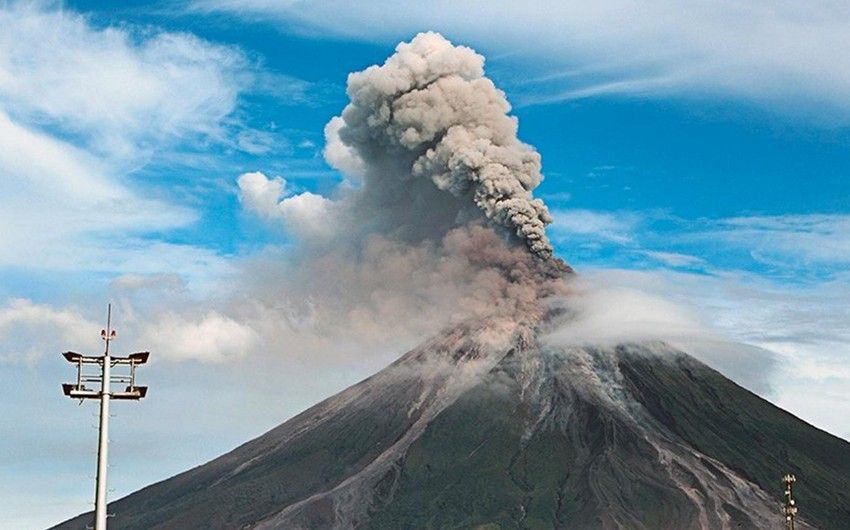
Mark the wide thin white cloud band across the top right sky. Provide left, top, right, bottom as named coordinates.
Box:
left=194, top=0, right=850, bottom=121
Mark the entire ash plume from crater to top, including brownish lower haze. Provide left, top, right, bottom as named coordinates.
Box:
left=239, top=33, right=569, bottom=356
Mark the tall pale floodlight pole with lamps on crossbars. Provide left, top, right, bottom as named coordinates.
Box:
left=62, top=304, right=150, bottom=530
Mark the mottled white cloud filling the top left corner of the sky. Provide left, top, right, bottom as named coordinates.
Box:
left=0, top=3, right=249, bottom=159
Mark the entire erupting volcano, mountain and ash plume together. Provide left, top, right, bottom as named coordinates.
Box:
left=46, top=32, right=850, bottom=530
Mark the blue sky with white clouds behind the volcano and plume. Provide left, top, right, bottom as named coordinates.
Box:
left=0, top=0, right=850, bottom=529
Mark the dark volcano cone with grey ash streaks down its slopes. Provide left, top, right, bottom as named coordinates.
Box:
left=56, top=322, right=850, bottom=530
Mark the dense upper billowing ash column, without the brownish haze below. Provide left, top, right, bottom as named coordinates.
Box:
left=339, top=33, right=552, bottom=259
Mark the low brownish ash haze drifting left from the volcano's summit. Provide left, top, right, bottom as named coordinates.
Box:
left=238, top=224, right=564, bottom=353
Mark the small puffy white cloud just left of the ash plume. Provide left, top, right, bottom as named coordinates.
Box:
left=237, top=172, right=335, bottom=237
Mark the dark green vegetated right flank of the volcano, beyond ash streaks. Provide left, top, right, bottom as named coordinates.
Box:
left=619, top=348, right=850, bottom=530
